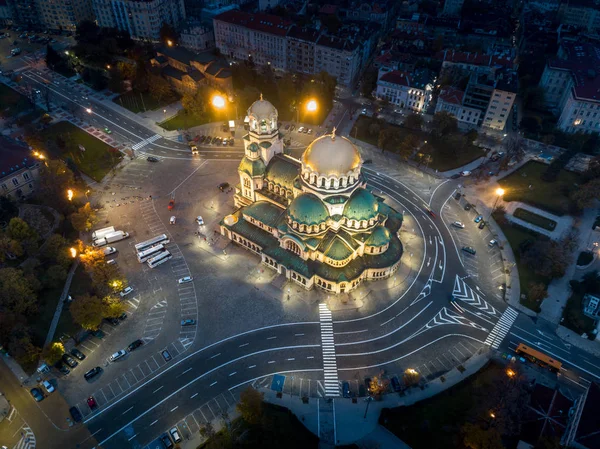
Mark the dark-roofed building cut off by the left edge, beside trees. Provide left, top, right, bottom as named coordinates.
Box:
left=0, top=136, right=40, bottom=200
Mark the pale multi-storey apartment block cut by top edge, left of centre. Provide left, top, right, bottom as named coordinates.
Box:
left=91, top=0, right=185, bottom=41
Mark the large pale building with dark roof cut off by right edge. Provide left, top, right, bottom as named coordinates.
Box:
left=540, top=42, right=600, bottom=133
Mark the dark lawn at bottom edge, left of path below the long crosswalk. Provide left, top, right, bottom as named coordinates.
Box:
left=198, top=403, right=319, bottom=449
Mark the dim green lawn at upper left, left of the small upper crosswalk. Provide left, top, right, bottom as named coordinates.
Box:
left=40, top=122, right=123, bottom=182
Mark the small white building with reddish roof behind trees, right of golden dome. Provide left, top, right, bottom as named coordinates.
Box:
left=375, top=69, right=434, bottom=113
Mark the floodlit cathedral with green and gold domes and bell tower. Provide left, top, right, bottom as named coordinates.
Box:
left=220, top=96, right=402, bottom=293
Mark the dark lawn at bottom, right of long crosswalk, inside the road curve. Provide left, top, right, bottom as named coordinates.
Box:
left=379, top=363, right=505, bottom=449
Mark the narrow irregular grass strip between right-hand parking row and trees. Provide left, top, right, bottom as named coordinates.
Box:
left=494, top=212, right=550, bottom=312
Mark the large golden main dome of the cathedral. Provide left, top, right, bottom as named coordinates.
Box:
left=302, top=134, right=361, bottom=176
